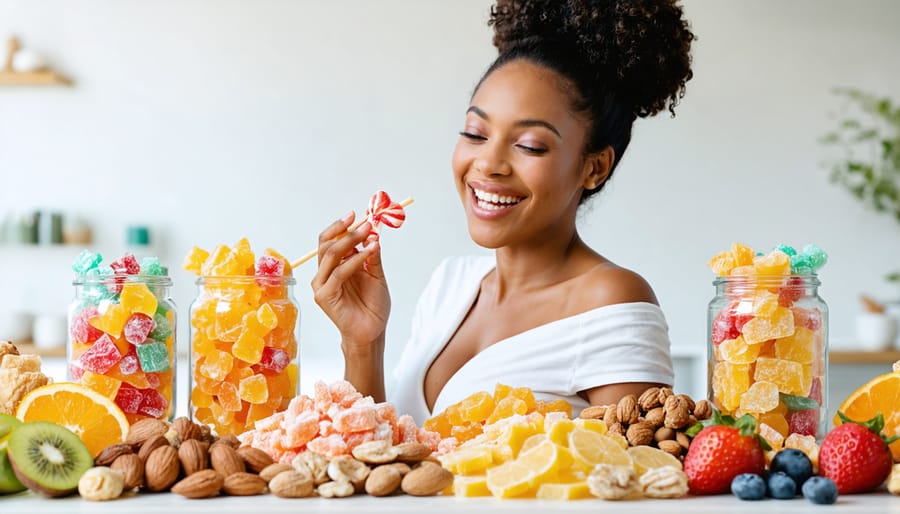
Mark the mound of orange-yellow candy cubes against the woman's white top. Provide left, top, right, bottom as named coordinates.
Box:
left=423, top=384, right=572, bottom=443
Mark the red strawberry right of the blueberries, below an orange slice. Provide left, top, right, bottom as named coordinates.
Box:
left=819, top=412, right=898, bottom=494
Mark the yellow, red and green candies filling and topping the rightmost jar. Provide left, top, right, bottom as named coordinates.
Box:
left=708, top=243, right=827, bottom=442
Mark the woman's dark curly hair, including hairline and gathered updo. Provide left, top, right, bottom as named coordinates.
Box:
left=482, top=0, right=695, bottom=198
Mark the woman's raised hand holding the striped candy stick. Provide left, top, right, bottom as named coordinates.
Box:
left=311, top=212, right=391, bottom=352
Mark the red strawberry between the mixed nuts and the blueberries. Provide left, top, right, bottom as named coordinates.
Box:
left=684, top=411, right=769, bottom=494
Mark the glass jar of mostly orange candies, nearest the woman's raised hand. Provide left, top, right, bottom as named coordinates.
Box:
left=190, top=276, right=300, bottom=436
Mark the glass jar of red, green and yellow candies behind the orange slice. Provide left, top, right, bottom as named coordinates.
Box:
left=66, top=273, right=176, bottom=423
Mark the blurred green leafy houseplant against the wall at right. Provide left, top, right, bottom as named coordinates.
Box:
left=821, top=88, right=900, bottom=282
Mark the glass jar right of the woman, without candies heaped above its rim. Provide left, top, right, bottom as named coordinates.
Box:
left=707, top=275, right=828, bottom=438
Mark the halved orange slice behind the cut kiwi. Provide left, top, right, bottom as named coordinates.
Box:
left=16, top=382, right=129, bottom=457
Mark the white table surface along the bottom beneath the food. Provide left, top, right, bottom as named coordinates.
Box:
left=0, top=492, right=900, bottom=514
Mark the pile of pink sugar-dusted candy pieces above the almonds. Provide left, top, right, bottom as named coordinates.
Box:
left=238, top=380, right=441, bottom=464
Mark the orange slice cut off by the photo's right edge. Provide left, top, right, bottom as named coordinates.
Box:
left=834, top=372, right=900, bottom=461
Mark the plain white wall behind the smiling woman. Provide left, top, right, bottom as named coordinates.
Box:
left=0, top=0, right=900, bottom=396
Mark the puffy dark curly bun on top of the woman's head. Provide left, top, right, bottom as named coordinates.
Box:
left=488, top=0, right=694, bottom=117
